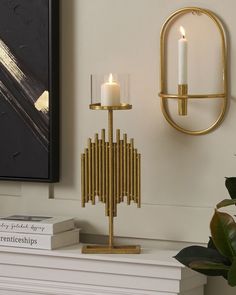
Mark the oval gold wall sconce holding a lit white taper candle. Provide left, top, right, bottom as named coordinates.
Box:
left=159, top=7, right=228, bottom=135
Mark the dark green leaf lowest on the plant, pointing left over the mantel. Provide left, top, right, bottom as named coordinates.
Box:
left=175, top=246, right=230, bottom=278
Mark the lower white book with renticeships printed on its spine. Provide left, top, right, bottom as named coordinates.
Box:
left=0, top=229, right=80, bottom=250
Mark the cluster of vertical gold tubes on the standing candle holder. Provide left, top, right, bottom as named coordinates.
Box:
left=81, top=135, right=140, bottom=207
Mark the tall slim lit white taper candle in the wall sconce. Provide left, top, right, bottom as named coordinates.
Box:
left=178, top=26, right=188, bottom=85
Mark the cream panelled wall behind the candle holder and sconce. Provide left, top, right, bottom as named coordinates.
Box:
left=0, top=0, right=236, bottom=295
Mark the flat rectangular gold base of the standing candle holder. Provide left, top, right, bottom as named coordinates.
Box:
left=82, top=245, right=141, bottom=254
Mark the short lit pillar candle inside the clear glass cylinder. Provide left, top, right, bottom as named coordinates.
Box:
left=101, top=74, right=120, bottom=106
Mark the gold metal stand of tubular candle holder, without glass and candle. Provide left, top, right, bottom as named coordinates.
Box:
left=81, top=103, right=141, bottom=254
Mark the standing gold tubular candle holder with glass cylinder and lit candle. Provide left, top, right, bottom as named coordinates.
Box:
left=81, top=74, right=141, bottom=254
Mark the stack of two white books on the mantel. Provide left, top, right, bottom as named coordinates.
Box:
left=0, top=215, right=79, bottom=250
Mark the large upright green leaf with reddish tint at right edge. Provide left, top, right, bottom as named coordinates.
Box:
left=210, top=210, right=236, bottom=261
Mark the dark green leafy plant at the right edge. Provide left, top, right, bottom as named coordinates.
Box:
left=175, top=177, right=236, bottom=287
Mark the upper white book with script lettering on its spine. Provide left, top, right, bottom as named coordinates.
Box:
left=0, top=215, right=75, bottom=235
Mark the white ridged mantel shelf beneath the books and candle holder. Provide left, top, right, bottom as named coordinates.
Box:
left=0, top=246, right=206, bottom=295
